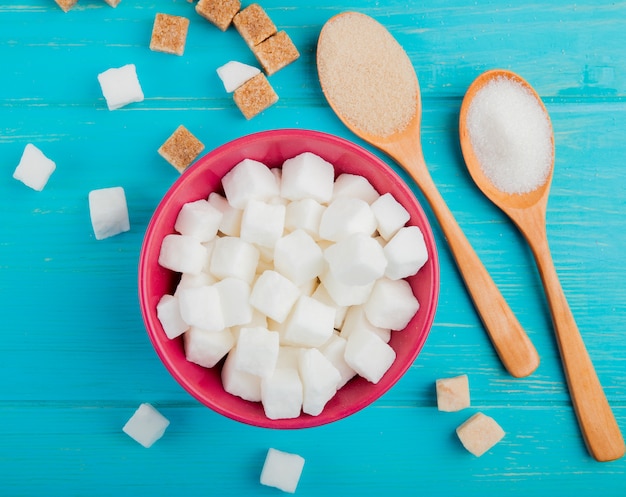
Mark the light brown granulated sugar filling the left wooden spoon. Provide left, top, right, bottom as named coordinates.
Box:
left=317, top=12, right=419, bottom=136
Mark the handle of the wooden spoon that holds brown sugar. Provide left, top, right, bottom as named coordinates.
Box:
left=414, top=174, right=539, bottom=378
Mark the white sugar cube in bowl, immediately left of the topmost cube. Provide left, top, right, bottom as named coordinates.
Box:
left=222, top=159, right=280, bottom=209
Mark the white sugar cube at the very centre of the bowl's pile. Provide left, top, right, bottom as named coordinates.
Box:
left=274, top=229, right=325, bottom=285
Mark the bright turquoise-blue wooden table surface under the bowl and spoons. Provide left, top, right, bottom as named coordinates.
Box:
left=0, top=0, right=626, bottom=497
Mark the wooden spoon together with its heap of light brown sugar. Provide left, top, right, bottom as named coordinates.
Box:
left=317, top=12, right=539, bottom=377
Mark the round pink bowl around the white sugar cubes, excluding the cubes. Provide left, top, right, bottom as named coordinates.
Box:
left=139, top=129, right=439, bottom=429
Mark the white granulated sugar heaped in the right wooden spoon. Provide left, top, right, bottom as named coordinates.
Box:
left=467, top=76, right=554, bottom=194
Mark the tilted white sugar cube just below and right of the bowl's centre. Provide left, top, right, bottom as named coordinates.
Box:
left=283, top=295, right=335, bottom=347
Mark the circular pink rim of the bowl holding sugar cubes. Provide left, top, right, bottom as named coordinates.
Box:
left=138, top=128, right=440, bottom=429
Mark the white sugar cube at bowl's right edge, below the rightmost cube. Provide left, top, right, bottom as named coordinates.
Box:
left=365, top=278, right=419, bottom=330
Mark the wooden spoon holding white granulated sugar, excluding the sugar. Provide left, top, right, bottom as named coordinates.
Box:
left=459, top=70, right=624, bottom=461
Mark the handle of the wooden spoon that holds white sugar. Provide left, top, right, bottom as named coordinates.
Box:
left=529, top=237, right=625, bottom=461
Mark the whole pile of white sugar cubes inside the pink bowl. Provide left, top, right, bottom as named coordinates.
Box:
left=157, top=152, right=428, bottom=419
